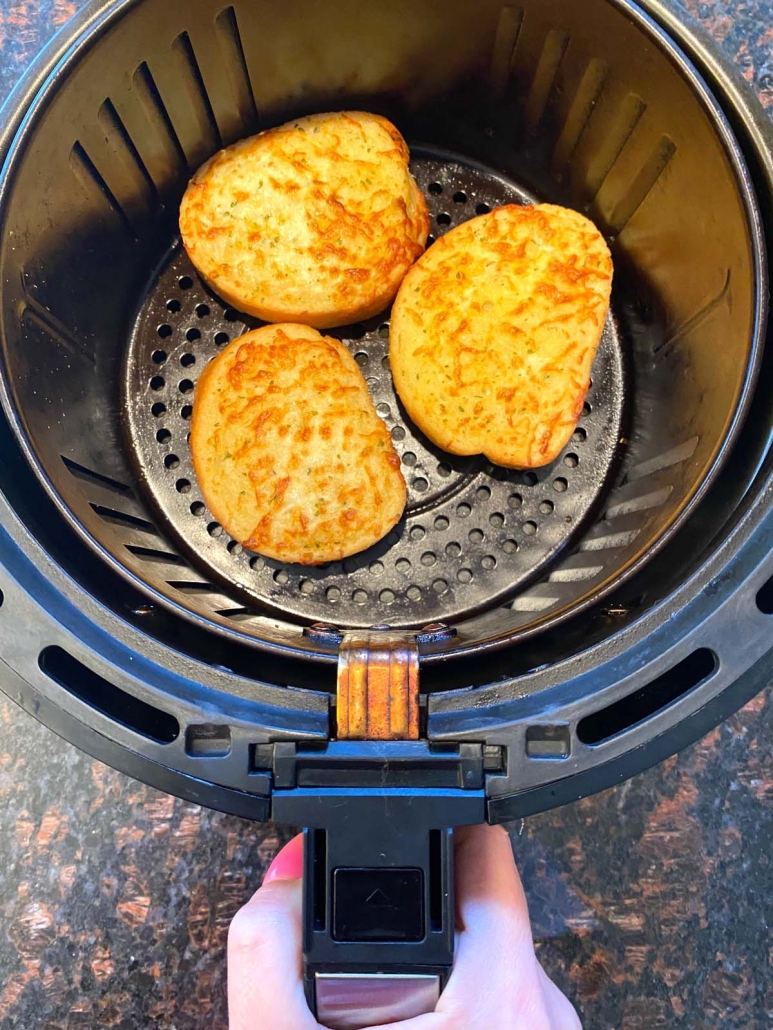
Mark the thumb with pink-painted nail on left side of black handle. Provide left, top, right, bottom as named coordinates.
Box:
left=228, top=835, right=318, bottom=1030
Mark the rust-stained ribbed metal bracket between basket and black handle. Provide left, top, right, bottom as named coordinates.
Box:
left=336, top=629, right=418, bottom=741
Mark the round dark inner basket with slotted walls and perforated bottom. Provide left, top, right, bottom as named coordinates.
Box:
left=2, top=0, right=761, bottom=651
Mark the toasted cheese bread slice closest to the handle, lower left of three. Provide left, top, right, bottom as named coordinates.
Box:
left=191, top=324, right=406, bottom=564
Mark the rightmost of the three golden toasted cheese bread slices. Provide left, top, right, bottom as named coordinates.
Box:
left=390, top=204, right=612, bottom=469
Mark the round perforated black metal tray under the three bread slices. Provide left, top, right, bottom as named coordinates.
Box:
left=125, top=148, right=624, bottom=627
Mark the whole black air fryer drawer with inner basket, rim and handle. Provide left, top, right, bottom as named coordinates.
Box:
left=0, top=0, right=773, bottom=1025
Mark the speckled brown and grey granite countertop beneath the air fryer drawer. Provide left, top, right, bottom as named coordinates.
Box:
left=0, top=0, right=773, bottom=1030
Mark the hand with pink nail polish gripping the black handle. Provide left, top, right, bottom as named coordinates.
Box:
left=228, top=826, right=581, bottom=1030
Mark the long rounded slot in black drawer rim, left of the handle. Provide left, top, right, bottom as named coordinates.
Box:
left=38, top=646, right=179, bottom=744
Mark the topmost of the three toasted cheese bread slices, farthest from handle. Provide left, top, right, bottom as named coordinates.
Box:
left=179, top=111, right=429, bottom=329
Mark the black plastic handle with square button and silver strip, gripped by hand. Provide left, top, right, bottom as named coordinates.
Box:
left=273, top=742, right=484, bottom=1030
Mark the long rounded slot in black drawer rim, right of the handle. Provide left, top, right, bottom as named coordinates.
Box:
left=577, top=648, right=717, bottom=744
